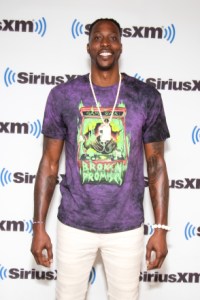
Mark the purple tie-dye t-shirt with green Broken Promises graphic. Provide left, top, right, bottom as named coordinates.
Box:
left=42, top=73, right=169, bottom=233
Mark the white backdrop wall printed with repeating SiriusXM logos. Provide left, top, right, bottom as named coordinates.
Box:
left=0, top=0, right=200, bottom=300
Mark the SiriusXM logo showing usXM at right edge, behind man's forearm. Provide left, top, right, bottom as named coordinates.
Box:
left=144, top=177, right=200, bottom=190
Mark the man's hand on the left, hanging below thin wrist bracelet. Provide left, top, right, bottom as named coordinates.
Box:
left=31, top=229, right=53, bottom=268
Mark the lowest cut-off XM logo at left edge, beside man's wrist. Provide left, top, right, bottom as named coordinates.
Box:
left=0, top=220, right=33, bottom=233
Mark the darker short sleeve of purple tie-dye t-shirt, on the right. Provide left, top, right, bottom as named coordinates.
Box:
left=143, top=90, right=170, bottom=143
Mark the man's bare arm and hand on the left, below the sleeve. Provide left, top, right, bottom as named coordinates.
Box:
left=31, top=137, right=64, bottom=267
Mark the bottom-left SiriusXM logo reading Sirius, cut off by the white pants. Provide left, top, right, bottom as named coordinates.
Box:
left=0, top=265, right=57, bottom=280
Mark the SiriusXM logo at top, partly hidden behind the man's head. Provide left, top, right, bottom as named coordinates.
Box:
left=71, top=19, right=176, bottom=44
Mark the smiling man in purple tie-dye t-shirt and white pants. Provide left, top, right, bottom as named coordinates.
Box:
left=31, top=19, right=169, bottom=300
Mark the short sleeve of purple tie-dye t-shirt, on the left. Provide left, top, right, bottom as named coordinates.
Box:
left=42, top=88, right=67, bottom=140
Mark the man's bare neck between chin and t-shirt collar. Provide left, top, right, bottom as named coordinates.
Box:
left=91, top=69, right=119, bottom=87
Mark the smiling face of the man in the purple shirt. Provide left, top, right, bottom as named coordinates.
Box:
left=87, top=21, right=122, bottom=70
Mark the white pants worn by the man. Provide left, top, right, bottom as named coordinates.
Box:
left=56, top=221, right=144, bottom=300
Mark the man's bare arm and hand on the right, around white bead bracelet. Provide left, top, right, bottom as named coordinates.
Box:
left=144, top=142, right=169, bottom=270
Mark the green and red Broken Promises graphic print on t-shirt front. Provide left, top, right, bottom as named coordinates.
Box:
left=77, top=104, right=130, bottom=185
